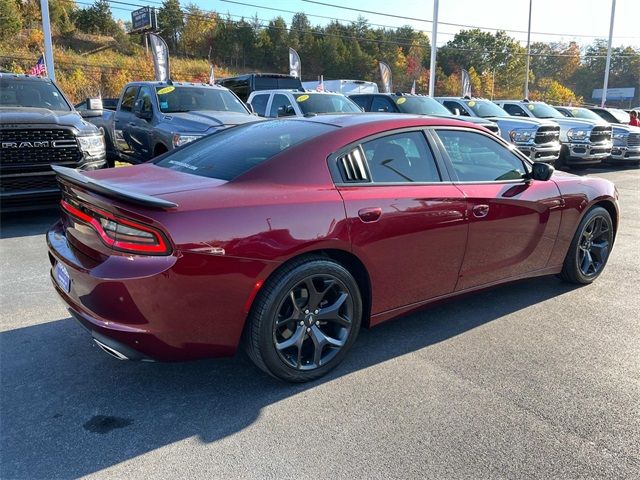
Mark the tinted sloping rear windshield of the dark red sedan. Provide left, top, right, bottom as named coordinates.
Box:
left=155, top=120, right=338, bottom=181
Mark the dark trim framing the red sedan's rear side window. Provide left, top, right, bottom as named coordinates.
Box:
left=327, top=126, right=453, bottom=188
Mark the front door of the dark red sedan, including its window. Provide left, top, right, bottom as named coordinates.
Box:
left=434, top=128, right=563, bottom=290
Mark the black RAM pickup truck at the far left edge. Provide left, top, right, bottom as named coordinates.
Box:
left=0, top=73, right=106, bottom=212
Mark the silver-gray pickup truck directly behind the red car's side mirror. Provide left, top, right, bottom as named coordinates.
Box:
left=436, top=97, right=560, bottom=164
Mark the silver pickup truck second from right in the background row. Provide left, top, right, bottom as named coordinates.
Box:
left=495, top=100, right=612, bottom=168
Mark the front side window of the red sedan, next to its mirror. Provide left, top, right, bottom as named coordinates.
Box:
left=436, top=130, right=527, bottom=182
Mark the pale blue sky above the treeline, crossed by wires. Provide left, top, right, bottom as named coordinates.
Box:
left=112, top=0, right=640, bottom=48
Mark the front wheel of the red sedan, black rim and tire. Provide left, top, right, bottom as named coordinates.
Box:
left=560, top=207, right=614, bottom=285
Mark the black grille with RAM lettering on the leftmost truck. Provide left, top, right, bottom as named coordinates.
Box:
left=0, top=128, right=82, bottom=167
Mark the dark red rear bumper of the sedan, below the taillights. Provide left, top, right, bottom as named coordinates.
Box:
left=47, top=222, right=266, bottom=361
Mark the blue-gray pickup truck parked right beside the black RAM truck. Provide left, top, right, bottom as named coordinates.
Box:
left=84, top=82, right=262, bottom=163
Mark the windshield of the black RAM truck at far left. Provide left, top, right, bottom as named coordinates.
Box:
left=0, top=77, right=71, bottom=112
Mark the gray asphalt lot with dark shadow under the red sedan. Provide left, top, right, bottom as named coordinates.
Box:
left=0, top=167, right=640, bottom=479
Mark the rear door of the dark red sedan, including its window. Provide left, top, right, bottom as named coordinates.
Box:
left=331, top=130, right=467, bottom=315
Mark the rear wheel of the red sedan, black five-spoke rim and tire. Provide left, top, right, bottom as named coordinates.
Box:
left=244, top=256, right=362, bottom=383
